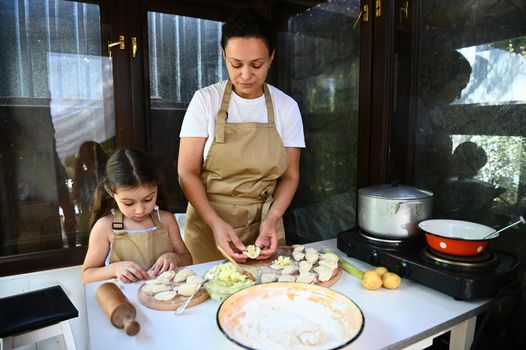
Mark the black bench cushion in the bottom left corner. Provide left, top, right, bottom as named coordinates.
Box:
left=0, top=286, right=79, bottom=338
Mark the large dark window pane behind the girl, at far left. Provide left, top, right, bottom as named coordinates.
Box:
left=0, top=0, right=115, bottom=256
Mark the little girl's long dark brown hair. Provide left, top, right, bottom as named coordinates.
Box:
left=90, top=148, right=159, bottom=229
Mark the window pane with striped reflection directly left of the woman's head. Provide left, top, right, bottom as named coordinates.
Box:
left=148, top=12, right=228, bottom=103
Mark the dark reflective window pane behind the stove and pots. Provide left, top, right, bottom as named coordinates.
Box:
left=414, top=1, right=526, bottom=229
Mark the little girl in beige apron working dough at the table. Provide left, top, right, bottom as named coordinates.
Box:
left=82, top=149, right=192, bottom=284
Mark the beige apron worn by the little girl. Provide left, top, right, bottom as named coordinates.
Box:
left=109, top=210, right=173, bottom=270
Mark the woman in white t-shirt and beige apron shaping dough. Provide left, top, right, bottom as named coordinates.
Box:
left=178, top=10, right=305, bottom=263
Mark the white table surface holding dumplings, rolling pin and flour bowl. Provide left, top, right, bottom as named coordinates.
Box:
left=85, top=239, right=490, bottom=350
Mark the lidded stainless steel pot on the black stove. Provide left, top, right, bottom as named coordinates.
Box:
left=358, top=185, right=433, bottom=240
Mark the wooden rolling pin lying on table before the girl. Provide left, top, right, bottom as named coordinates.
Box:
left=95, top=282, right=141, bottom=335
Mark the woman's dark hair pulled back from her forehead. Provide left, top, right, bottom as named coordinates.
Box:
left=221, top=8, right=275, bottom=54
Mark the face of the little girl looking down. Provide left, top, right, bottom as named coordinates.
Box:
left=113, top=185, right=157, bottom=222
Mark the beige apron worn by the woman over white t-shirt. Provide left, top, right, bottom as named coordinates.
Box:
left=184, top=80, right=288, bottom=263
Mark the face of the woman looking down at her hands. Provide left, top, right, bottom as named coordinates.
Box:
left=223, top=37, right=274, bottom=98
